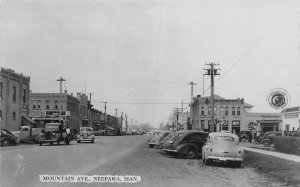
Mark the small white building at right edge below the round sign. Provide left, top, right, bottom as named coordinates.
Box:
left=281, top=106, right=300, bottom=131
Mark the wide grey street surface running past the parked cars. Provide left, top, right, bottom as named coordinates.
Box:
left=0, top=136, right=282, bottom=187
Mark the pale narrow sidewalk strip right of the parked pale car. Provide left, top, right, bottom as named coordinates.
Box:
left=240, top=142, right=300, bottom=162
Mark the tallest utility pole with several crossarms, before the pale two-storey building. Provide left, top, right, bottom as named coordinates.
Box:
left=204, top=62, right=220, bottom=132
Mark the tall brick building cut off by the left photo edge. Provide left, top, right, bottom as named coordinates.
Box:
left=0, top=68, right=30, bottom=131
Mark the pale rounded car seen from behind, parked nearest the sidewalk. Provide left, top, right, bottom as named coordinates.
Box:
left=202, top=132, right=244, bottom=167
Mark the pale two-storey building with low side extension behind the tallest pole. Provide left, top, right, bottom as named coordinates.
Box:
left=191, top=95, right=282, bottom=133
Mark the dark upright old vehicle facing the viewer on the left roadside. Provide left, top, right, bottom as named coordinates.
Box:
left=38, top=123, right=70, bottom=146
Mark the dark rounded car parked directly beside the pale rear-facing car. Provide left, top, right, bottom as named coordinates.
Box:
left=163, top=130, right=208, bottom=159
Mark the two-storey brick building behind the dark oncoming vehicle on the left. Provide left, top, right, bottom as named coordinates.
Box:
left=29, top=91, right=81, bottom=130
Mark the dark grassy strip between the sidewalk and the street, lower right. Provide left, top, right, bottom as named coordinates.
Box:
left=244, top=150, right=300, bottom=186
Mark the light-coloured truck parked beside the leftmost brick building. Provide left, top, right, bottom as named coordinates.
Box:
left=12, top=126, right=43, bottom=143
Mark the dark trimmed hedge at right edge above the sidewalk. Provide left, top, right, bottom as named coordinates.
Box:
left=274, top=136, right=300, bottom=155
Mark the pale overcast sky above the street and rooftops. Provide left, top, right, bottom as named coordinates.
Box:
left=0, top=0, right=300, bottom=127
